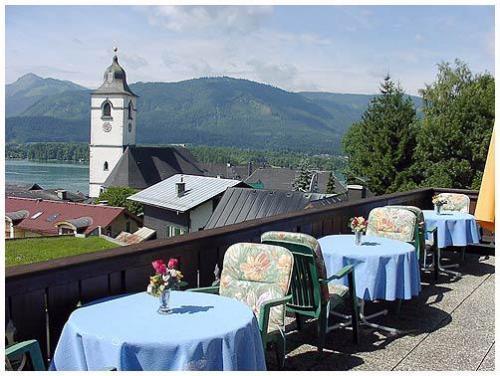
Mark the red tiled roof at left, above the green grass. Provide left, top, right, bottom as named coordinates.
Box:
left=5, top=197, right=125, bottom=234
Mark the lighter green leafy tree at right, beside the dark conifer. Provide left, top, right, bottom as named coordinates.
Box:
left=413, top=60, right=495, bottom=189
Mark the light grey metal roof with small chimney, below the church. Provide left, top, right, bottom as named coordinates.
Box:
left=128, top=174, right=246, bottom=212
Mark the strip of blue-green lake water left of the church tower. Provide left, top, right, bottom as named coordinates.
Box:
left=5, top=159, right=89, bottom=194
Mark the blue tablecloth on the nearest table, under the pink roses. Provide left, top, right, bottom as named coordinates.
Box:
left=51, top=291, right=266, bottom=370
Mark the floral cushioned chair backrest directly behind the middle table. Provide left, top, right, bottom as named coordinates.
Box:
left=366, top=206, right=417, bottom=243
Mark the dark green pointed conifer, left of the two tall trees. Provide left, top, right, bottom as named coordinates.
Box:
left=343, top=76, right=417, bottom=194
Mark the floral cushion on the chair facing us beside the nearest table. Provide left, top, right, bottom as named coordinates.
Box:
left=219, top=243, right=293, bottom=332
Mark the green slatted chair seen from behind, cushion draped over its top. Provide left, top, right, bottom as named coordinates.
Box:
left=261, top=231, right=359, bottom=351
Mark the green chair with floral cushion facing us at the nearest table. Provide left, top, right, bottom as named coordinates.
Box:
left=188, top=243, right=294, bottom=368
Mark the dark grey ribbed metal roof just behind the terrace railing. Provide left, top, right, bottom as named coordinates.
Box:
left=205, top=188, right=340, bottom=229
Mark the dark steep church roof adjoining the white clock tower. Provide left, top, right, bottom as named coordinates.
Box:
left=104, top=146, right=204, bottom=189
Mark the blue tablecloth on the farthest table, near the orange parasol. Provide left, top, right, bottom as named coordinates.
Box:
left=423, top=210, right=479, bottom=248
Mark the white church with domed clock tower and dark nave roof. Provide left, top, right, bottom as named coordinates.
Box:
left=89, top=53, right=204, bottom=198
